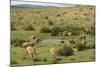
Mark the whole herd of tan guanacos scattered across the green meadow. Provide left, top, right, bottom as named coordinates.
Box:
left=21, top=31, right=86, bottom=61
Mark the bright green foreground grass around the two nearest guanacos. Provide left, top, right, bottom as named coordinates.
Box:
left=11, top=46, right=95, bottom=65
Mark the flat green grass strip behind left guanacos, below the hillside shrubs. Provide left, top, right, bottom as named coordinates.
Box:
left=11, top=31, right=58, bottom=39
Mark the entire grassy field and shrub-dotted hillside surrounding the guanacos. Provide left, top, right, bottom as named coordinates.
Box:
left=11, top=6, right=95, bottom=65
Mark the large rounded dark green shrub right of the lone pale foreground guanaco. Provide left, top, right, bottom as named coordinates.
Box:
left=57, top=45, right=74, bottom=56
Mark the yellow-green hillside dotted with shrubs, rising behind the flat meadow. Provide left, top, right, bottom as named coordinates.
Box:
left=11, top=6, right=95, bottom=35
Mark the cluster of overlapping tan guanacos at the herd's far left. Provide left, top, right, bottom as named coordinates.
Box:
left=22, top=35, right=41, bottom=59
